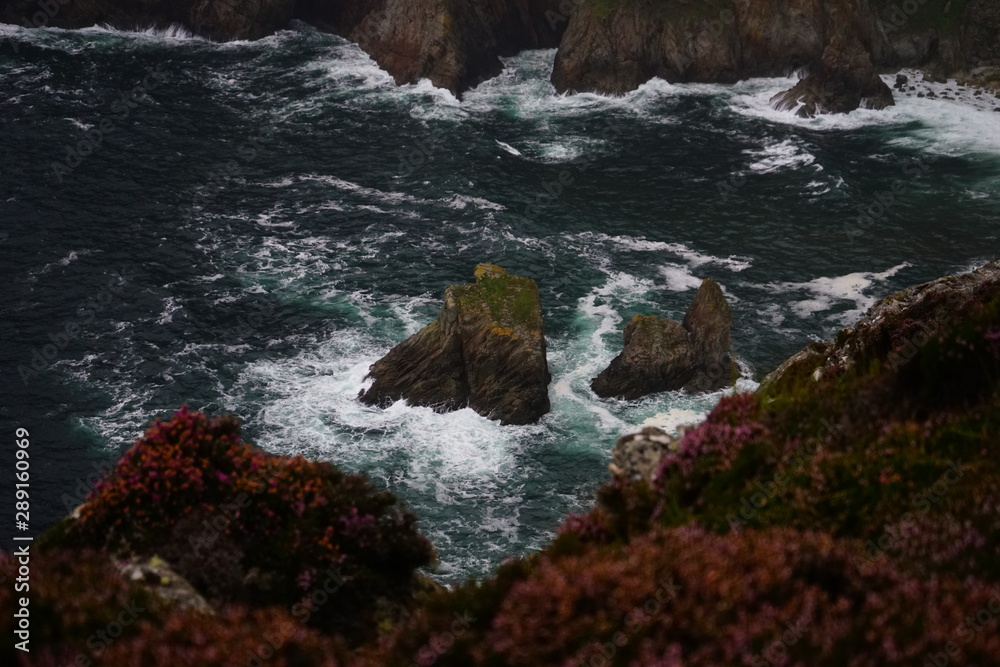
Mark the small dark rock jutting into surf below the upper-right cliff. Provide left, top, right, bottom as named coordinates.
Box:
left=771, top=39, right=895, bottom=118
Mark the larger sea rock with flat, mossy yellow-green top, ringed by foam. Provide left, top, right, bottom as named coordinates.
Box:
left=358, top=264, right=551, bottom=424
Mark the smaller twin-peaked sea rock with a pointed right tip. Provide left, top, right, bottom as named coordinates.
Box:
left=590, top=279, right=738, bottom=400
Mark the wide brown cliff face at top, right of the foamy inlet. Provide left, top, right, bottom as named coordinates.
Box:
left=552, top=0, right=1000, bottom=94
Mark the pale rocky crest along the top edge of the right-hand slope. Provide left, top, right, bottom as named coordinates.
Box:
left=757, top=260, right=1000, bottom=396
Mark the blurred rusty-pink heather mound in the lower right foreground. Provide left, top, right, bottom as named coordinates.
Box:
left=359, top=527, right=1000, bottom=667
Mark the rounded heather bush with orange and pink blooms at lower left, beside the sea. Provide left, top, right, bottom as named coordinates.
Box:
left=48, top=409, right=434, bottom=636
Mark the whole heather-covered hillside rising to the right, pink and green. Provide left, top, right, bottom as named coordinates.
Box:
left=368, top=268, right=1000, bottom=666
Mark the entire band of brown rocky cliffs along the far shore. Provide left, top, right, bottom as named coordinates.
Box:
left=7, top=0, right=1000, bottom=108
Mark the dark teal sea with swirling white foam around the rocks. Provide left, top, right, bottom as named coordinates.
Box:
left=0, top=25, right=1000, bottom=582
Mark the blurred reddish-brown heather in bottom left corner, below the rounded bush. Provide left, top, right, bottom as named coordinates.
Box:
left=0, top=549, right=343, bottom=667
